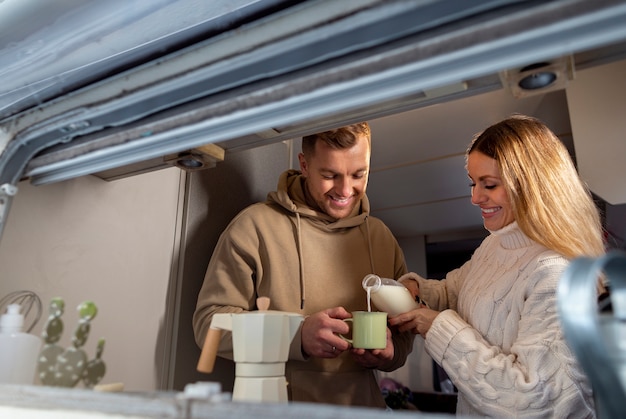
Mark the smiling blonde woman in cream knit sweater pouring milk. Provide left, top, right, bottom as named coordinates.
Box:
left=389, top=115, right=604, bottom=418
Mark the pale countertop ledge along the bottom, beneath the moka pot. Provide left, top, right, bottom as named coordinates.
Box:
left=0, top=385, right=455, bottom=419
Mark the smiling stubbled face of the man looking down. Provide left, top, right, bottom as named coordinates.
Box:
left=298, top=136, right=370, bottom=219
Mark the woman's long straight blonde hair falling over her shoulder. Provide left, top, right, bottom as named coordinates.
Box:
left=466, top=115, right=605, bottom=259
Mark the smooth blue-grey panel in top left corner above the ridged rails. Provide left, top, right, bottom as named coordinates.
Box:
left=0, top=0, right=293, bottom=118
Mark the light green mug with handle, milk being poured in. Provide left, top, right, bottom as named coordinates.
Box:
left=339, top=311, right=387, bottom=349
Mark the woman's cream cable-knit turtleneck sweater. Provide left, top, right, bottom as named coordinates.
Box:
left=418, top=223, right=595, bottom=418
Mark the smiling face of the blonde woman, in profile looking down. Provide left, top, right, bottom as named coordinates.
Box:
left=467, top=151, right=515, bottom=231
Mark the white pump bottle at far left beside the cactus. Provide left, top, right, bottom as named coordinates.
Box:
left=0, top=304, right=41, bottom=384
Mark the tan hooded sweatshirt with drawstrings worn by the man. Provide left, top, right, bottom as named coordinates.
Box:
left=193, top=170, right=413, bottom=407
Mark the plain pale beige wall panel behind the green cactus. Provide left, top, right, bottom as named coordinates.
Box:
left=0, top=168, right=181, bottom=391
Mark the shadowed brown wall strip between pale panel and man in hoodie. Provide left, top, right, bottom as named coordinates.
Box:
left=164, top=141, right=292, bottom=391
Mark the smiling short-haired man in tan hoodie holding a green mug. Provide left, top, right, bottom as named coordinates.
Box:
left=193, top=122, right=413, bottom=407
